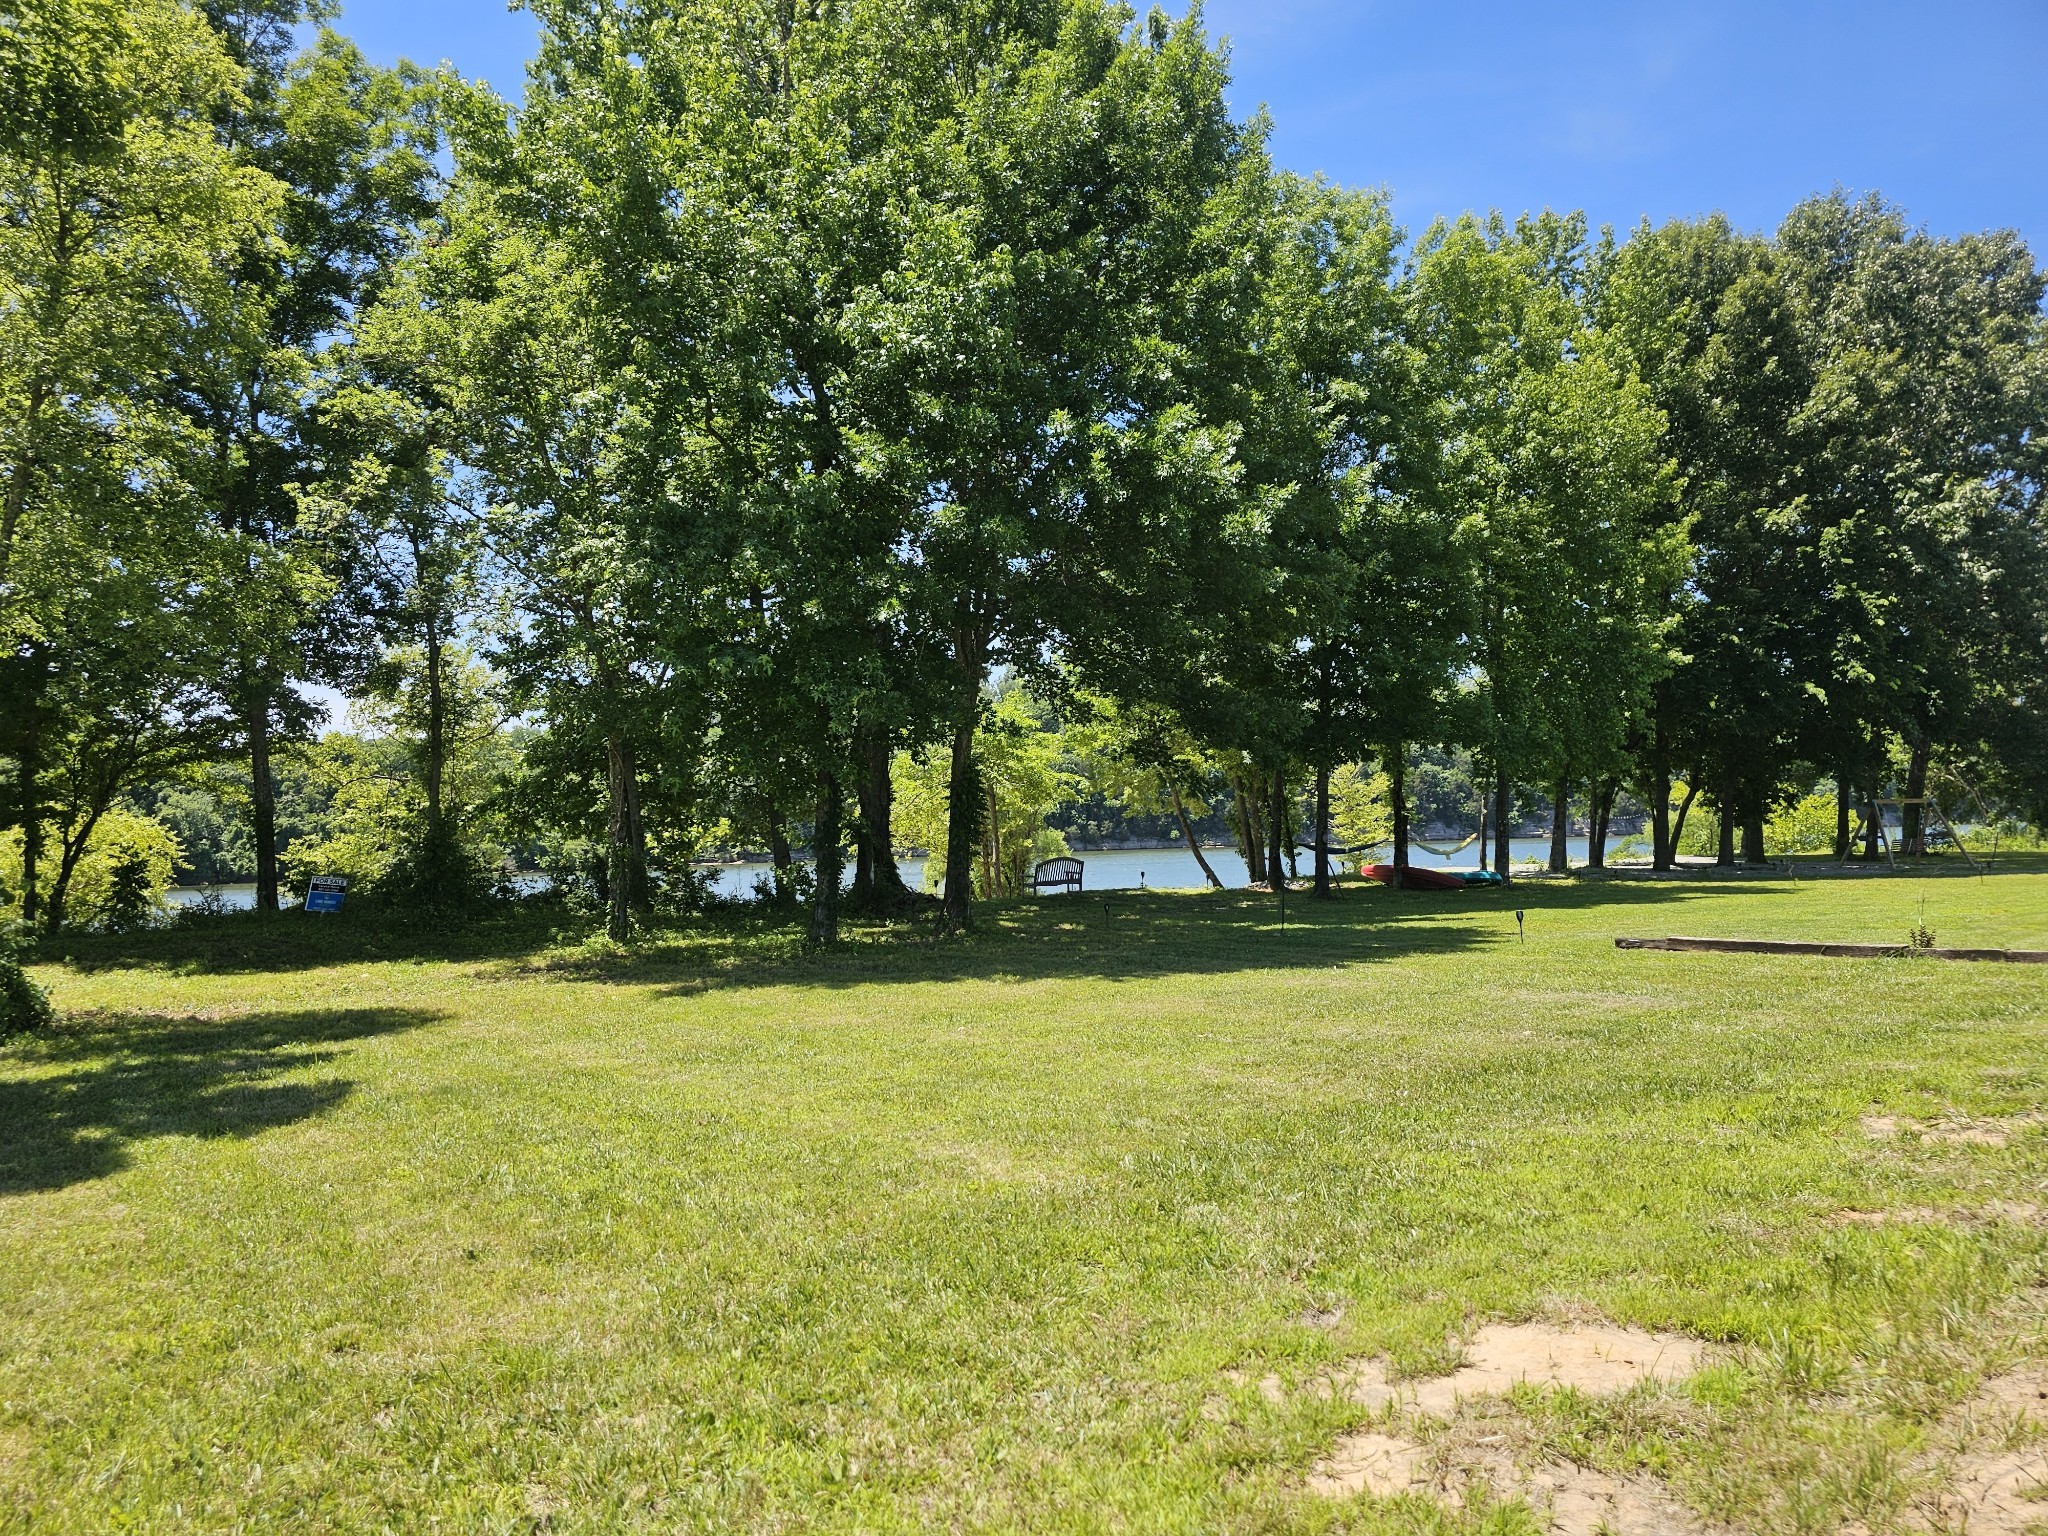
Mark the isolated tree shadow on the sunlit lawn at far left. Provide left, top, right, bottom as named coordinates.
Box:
left=0, top=1008, right=440, bottom=1196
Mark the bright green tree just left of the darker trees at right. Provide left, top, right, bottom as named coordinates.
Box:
left=1409, top=215, right=1688, bottom=888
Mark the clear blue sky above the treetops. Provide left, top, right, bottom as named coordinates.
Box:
left=327, top=0, right=2048, bottom=250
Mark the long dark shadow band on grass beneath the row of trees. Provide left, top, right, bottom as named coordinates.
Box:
left=41, top=860, right=2023, bottom=989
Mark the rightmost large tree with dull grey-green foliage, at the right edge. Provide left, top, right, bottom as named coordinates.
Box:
left=1776, top=193, right=2044, bottom=848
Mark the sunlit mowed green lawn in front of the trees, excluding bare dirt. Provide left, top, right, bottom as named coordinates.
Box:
left=0, top=864, right=2048, bottom=1532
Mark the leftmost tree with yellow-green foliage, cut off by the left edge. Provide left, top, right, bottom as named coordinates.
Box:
left=0, top=0, right=279, bottom=920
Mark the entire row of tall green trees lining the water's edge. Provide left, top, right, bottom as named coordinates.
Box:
left=0, top=0, right=2048, bottom=938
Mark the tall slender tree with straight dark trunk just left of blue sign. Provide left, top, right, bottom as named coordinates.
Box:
left=170, top=0, right=440, bottom=911
